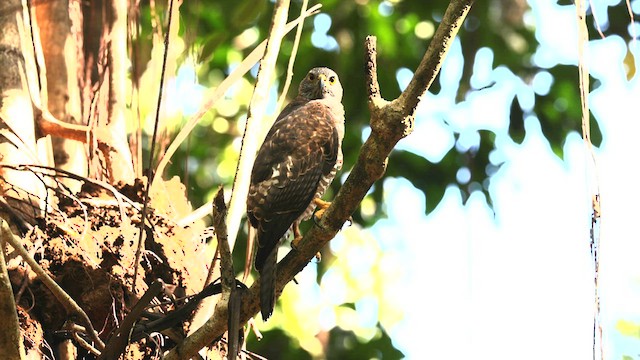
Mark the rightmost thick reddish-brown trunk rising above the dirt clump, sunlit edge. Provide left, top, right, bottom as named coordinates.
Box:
left=74, top=0, right=135, bottom=184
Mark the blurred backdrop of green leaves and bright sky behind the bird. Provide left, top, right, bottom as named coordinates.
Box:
left=134, top=0, right=640, bottom=360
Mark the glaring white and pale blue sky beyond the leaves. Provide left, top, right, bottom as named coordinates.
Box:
left=166, top=0, right=640, bottom=359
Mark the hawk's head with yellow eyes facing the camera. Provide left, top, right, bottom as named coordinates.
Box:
left=298, top=67, right=342, bottom=101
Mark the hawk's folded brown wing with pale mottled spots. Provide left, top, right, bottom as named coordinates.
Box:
left=247, top=101, right=339, bottom=269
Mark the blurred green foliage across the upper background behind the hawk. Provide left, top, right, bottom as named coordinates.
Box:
left=142, top=0, right=634, bottom=357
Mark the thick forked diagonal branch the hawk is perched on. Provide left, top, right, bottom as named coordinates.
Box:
left=167, top=0, right=474, bottom=352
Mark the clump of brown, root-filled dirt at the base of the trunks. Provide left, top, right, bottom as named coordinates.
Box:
left=9, top=178, right=211, bottom=359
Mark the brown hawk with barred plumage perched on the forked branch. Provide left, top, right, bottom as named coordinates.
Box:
left=247, top=67, right=344, bottom=321
